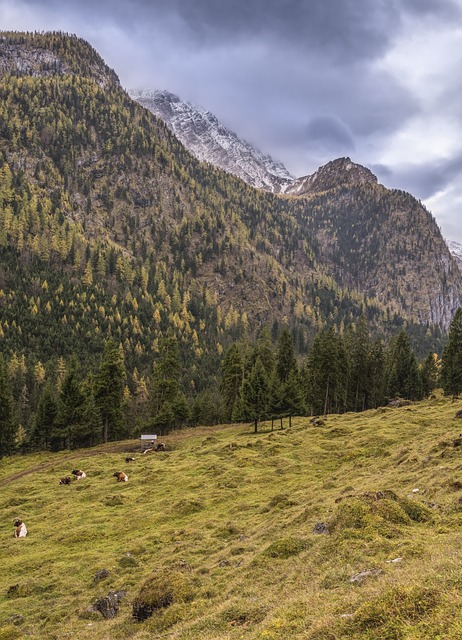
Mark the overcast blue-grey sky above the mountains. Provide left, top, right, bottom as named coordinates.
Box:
left=0, top=0, right=462, bottom=243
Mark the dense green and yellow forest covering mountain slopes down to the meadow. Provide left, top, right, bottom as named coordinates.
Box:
left=0, top=33, right=460, bottom=452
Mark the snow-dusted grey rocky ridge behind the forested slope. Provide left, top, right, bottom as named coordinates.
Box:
left=129, top=89, right=294, bottom=193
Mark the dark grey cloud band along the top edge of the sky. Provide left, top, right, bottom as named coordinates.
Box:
left=16, top=0, right=436, bottom=64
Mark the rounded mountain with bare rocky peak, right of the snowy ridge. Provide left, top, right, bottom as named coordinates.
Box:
left=293, top=158, right=462, bottom=328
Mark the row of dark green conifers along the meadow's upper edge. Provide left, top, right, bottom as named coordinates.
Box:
left=0, top=309, right=462, bottom=456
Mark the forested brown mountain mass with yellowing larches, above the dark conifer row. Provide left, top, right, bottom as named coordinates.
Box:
left=0, top=33, right=460, bottom=392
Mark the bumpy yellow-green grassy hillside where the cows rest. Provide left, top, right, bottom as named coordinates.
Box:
left=0, top=397, right=462, bottom=640
